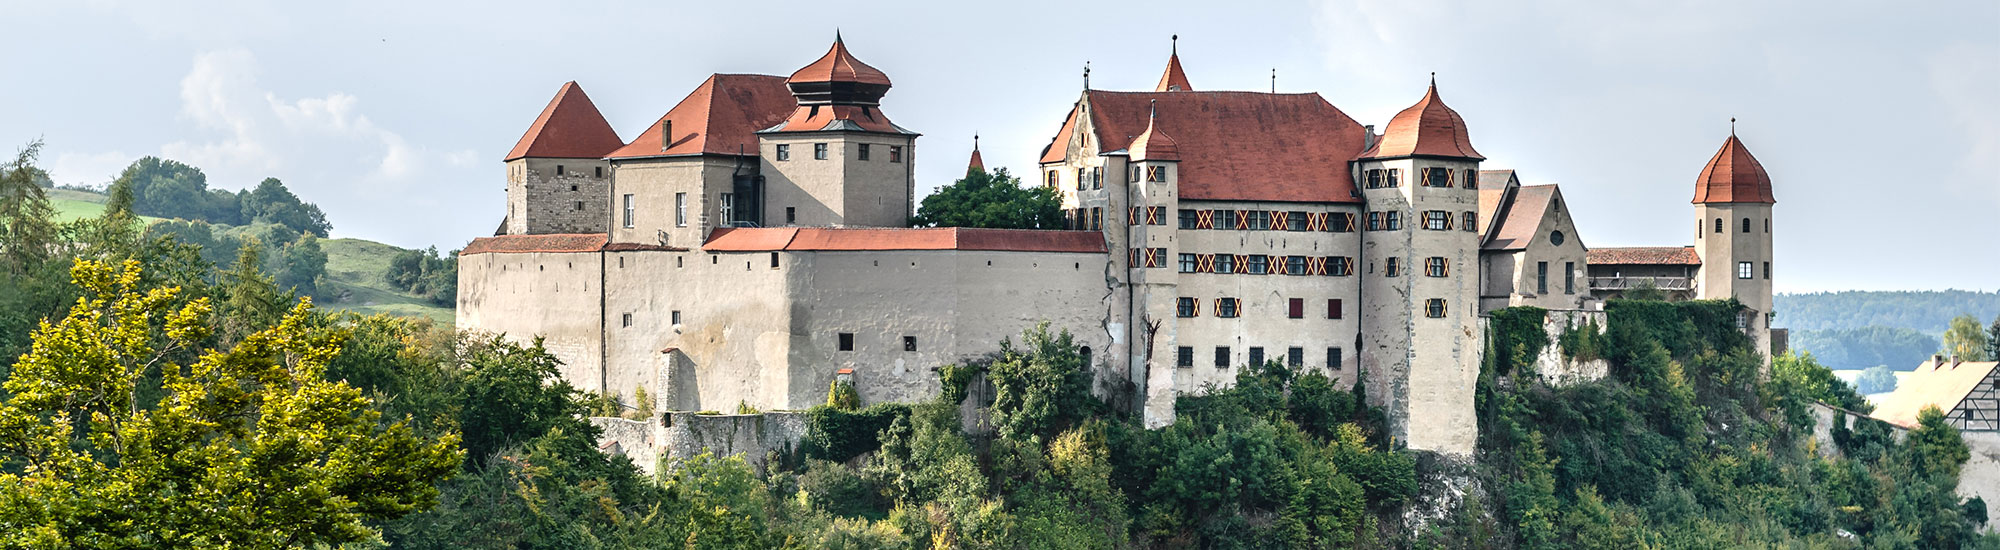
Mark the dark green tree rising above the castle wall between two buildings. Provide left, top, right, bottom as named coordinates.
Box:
left=910, top=168, right=1062, bottom=230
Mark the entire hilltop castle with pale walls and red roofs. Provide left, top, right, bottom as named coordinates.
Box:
left=458, top=38, right=1772, bottom=454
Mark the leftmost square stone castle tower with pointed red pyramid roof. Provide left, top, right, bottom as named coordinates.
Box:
left=500, top=80, right=624, bottom=234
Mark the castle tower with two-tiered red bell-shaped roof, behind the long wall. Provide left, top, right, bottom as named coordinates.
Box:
left=758, top=34, right=918, bottom=228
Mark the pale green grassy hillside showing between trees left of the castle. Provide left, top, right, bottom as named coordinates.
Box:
left=48, top=190, right=454, bottom=326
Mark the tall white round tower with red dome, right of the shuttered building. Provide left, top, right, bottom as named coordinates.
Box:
left=1352, top=80, right=1484, bottom=454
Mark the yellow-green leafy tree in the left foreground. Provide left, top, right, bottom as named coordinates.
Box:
left=0, top=260, right=458, bottom=548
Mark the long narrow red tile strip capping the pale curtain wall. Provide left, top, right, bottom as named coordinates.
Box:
left=702, top=228, right=1104, bottom=254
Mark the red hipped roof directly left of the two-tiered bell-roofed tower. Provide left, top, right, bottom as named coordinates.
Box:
left=608, top=74, right=798, bottom=158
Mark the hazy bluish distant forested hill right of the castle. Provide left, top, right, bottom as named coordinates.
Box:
left=1774, top=290, right=2000, bottom=370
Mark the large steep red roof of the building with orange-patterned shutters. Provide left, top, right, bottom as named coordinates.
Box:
left=1042, top=90, right=1364, bottom=202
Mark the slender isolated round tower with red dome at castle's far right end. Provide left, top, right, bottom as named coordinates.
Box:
left=1694, top=128, right=1778, bottom=362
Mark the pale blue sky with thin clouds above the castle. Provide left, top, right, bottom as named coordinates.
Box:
left=0, top=0, right=2000, bottom=292
